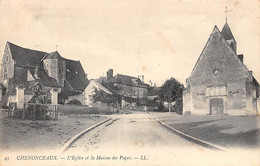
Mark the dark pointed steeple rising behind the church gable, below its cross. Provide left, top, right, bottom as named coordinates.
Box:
left=221, top=22, right=237, bottom=53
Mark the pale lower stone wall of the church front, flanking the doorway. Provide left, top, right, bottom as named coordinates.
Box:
left=183, top=80, right=257, bottom=115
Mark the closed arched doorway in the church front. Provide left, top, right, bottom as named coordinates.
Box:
left=210, top=98, right=224, bottom=115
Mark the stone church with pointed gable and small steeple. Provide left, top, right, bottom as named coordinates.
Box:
left=183, top=22, right=259, bottom=115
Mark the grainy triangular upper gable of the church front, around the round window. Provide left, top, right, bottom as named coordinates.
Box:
left=188, top=26, right=248, bottom=85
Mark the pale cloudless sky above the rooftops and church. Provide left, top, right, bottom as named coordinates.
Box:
left=0, top=0, right=260, bottom=86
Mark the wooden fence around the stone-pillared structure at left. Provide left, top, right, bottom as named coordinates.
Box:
left=8, top=103, right=59, bottom=120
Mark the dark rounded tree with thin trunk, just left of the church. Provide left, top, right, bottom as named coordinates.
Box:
left=159, top=77, right=183, bottom=112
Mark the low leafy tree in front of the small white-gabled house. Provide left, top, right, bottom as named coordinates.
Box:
left=91, top=88, right=121, bottom=111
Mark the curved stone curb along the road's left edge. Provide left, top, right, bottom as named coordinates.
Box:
left=59, top=118, right=112, bottom=154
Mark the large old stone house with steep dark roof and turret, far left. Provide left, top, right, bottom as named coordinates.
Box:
left=0, top=42, right=89, bottom=105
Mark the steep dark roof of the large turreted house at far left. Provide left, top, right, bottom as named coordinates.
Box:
left=7, top=42, right=89, bottom=92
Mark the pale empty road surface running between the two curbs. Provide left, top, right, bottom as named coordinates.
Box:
left=64, top=111, right=205, bottom=153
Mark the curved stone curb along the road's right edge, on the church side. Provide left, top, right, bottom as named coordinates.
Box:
left=148, top=112, right=229, bottom=152
